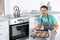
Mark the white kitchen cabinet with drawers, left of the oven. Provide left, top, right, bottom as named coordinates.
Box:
left=0, top=20, right=9, bottom=40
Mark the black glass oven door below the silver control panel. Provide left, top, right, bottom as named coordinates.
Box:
left=9, top=22, right=29, bottom=40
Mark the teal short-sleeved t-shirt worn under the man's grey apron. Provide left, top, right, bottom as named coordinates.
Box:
left=37, top=14, right=57, bottom=25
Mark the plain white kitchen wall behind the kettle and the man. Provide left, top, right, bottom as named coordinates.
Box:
left=4, top=0, right=60, bottom=14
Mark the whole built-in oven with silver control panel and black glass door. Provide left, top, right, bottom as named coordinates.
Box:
left=10, top=18, right=29, bottom=40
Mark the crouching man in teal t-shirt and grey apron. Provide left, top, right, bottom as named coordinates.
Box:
left=32, top=5, right=58, bottom=40
